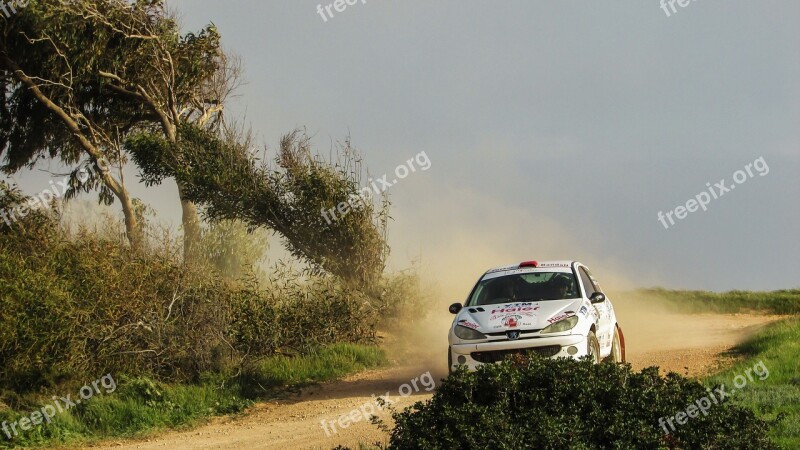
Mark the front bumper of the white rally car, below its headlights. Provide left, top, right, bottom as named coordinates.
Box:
left=448, top=334, right=588, bottom=370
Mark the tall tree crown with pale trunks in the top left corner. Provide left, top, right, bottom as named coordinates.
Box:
left=0, top=0, right=233, bottom=257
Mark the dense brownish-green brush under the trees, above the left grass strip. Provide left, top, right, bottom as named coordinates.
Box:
left=0, top=183, right=376, bottom=392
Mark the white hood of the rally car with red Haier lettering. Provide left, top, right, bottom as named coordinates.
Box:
left=456, top=298, right=583, bottom=333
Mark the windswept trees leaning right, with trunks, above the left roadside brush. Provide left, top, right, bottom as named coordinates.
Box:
left=0, top=0, right=388, bottom=284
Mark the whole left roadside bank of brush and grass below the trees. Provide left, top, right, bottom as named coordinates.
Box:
left=0, top=185, right=416, bottom=448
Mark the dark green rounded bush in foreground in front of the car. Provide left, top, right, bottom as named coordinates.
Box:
left=390, top=358, right=776, bottom=449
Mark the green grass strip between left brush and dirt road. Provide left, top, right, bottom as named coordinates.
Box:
left=0, top=344, right=387, bottom=448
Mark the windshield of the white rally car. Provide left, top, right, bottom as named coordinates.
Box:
left=466, top=272, right=580, bottom=306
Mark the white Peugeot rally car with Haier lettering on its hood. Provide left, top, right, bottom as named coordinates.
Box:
left=447, top=261, right=625, bottom=371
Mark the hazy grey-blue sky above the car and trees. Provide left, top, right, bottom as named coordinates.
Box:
left=3, top=0, right=800, bottom=294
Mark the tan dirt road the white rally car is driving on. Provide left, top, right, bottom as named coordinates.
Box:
left=89, top=309, right=776, bottom=450
